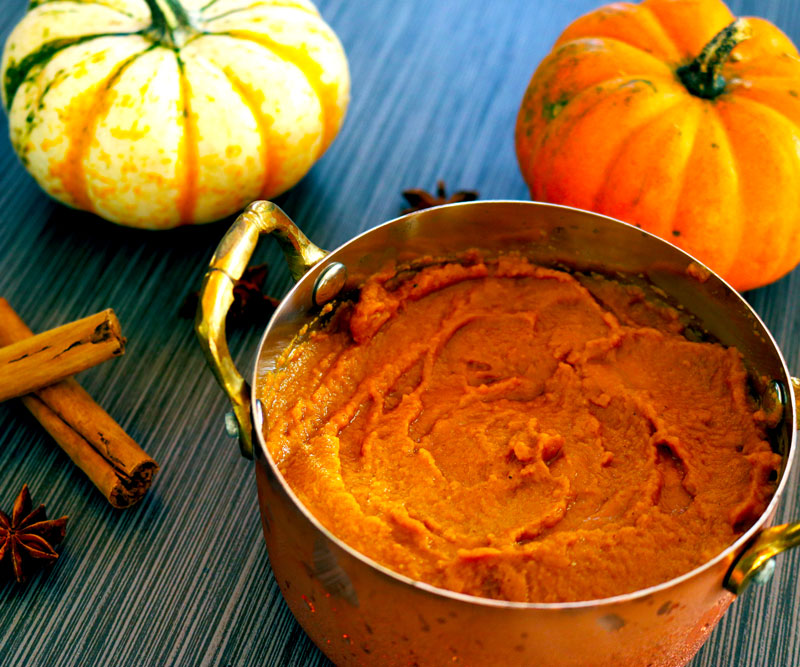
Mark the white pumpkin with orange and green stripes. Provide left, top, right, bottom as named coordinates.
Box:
left=2, top=0, right=350, bottom=229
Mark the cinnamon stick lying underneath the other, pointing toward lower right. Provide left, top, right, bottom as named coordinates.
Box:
left=0, top=299, right=158, bottom=508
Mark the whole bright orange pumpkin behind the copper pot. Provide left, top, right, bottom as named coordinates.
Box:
left=515, top=0, right=800, bottom=290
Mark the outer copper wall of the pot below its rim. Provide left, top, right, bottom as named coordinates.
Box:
left=256, top=455, right=734, bottom=667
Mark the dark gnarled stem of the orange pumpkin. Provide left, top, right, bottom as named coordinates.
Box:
left=678, top=19, right=753, bottom=100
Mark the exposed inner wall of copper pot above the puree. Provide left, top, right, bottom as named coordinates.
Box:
left=252, top=201, right=795, bottom=604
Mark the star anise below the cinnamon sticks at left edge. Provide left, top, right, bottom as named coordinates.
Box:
left=0, top=484, right=67, bottom=584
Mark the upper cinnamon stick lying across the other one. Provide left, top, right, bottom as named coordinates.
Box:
left=0, top=308, right=125, bottom=402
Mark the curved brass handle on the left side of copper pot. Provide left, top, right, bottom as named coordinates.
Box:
left=194, top=201, right=327, bottom=459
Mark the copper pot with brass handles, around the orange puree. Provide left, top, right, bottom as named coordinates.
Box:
left=196, top=201, right=800, bottom=667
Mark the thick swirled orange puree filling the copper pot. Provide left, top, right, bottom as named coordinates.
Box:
left=264, top=257, right=780, bottom=602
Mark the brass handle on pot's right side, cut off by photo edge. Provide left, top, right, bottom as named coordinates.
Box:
left=723, top=377, right=800, bottom=595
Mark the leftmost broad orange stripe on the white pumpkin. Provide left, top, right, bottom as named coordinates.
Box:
left=58, top=45, right=156, bottom=212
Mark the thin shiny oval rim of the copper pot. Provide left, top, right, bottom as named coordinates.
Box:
left=250, top=199, right=798, bottom=610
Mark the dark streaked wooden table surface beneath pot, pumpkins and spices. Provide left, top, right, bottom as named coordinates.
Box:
left=0, top=0, right=800, bottom=667
